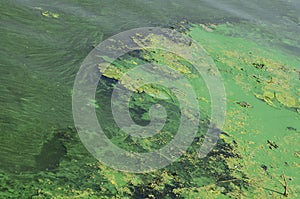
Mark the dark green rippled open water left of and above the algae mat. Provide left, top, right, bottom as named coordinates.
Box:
left=0, top=0, right=300, bottom=190
